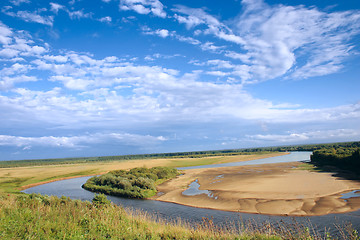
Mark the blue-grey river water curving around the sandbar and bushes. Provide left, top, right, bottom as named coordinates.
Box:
left=23, top=152, right=360, bottom=235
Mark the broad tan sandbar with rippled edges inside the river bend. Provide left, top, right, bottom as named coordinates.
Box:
left=154, top=162, right=360, bottom=216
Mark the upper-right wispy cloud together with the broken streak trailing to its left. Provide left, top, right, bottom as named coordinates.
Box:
left=172, top=0, right=360, bottom=83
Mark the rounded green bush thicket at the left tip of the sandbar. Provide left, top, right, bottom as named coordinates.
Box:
left=83, top=167, right=179, bottom=198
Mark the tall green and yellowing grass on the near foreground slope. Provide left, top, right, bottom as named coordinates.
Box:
left=0, top=194, right=359, bottom=239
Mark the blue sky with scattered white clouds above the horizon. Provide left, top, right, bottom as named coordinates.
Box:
left=0, top=0, right=360, bottom=160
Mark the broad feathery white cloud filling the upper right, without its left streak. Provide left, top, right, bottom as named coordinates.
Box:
left=233, top=1, right=360, bottom=80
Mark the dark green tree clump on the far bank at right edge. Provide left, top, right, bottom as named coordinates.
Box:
left=311, top=144, right=360, bottom=178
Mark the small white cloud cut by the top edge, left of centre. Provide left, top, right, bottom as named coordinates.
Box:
left=119, top=0, right=166, bottom=18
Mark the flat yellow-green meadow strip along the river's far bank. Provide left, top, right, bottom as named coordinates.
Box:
left=0, top=152, right=287, bottom=194
